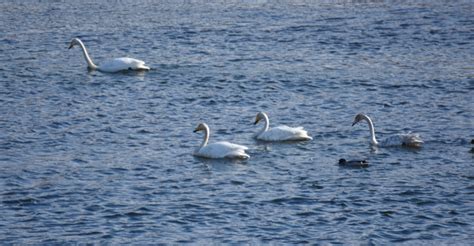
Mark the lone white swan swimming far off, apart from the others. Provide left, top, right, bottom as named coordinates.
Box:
left=69, top=38, right=150, bottom=73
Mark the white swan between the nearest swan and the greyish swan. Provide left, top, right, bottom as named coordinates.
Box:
left=254, top=112, right=313, bottom=141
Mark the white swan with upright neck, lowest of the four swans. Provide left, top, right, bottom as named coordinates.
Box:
left=194, top=123, right=250, bottom=159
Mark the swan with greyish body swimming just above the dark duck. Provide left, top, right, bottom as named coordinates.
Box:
left=352, top=113, right=423, bottom=147
